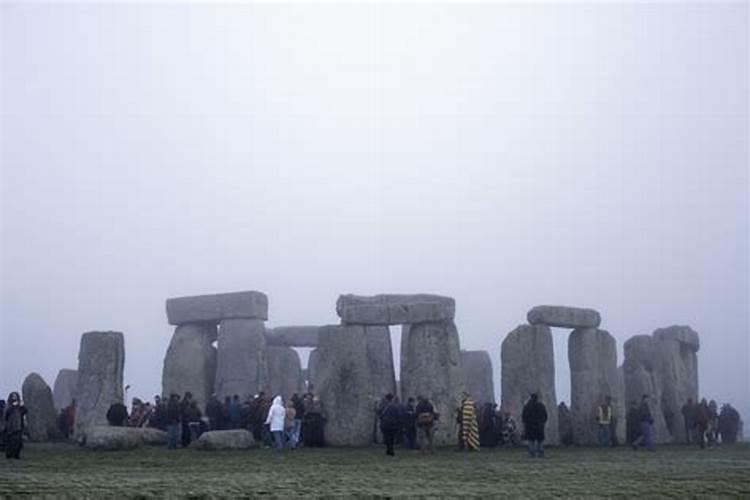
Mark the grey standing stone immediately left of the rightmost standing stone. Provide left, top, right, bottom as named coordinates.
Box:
left=623, top=335, right=671, bottom=443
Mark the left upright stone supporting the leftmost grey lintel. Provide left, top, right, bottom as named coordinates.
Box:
left=161, top=323, right=217, bottom=411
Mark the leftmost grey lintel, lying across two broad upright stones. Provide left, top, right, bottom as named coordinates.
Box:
left=167, top=291, right=268, bottom=325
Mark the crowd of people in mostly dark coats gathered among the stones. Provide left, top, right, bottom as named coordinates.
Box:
left=0, top=386, right=742, bottom=458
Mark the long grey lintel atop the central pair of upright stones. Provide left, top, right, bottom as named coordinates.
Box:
left=336, top=294, right=456, bottom=325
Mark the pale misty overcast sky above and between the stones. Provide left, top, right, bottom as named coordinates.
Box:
left=0, top=2, right=750, bottom=420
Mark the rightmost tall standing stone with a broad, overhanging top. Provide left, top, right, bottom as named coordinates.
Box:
left=653, top=326, right=700, bottom=442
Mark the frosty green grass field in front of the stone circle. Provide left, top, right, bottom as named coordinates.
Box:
left=0, top=444, right=750, bottom=498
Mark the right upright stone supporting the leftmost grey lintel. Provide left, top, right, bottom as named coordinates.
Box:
left=214, top=319, right=268, bottom=401
